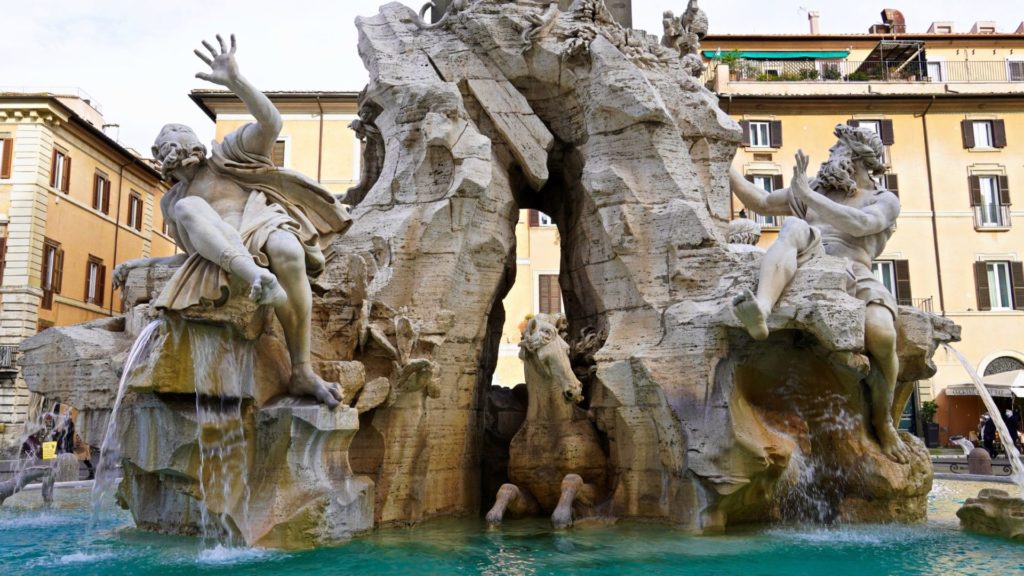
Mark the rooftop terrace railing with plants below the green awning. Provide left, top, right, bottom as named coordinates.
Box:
left=706, top=59, right=1024, bottom=83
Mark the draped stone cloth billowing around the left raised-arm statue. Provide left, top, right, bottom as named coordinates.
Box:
left=154, top=124, right=351, bottom=310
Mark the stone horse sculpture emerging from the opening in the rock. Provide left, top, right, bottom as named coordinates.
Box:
left=486, top=315, right=606, bottom=528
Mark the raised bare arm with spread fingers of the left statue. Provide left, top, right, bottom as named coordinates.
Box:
left=194, top=34, right=282, bottom=156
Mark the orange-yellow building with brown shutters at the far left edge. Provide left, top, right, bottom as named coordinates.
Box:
left=0, top=93, right=175, bottom=448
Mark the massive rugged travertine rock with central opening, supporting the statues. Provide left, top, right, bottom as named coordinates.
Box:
left=20, top=0, right=958, bottom=546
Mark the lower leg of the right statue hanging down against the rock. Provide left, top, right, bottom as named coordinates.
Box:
left=864, top=303, right=910, bottom=464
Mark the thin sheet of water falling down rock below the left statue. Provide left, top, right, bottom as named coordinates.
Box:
left=191, top=325, right=254, bottom=546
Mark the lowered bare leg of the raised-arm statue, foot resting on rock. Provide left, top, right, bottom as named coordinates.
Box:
left=264, top=231, right=341, bottom=408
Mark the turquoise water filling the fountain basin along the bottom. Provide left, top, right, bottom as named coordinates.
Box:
left=0, top=484, right=1024, bottom=576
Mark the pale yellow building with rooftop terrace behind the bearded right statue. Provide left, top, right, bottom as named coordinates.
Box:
left=703, top=16, right=1024, bottom=444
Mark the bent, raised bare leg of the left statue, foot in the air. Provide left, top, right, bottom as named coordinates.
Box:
left=174, top=196, right=287, bottom=306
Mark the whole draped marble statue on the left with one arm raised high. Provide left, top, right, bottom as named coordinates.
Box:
left=114, top=35, right=349, bottom=407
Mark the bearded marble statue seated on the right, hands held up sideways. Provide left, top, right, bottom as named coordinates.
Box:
left=729, top=125, right=909, bottom=463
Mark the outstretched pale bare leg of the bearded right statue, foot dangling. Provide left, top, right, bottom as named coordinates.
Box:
left=732, top=218, right=813, bottom=340
